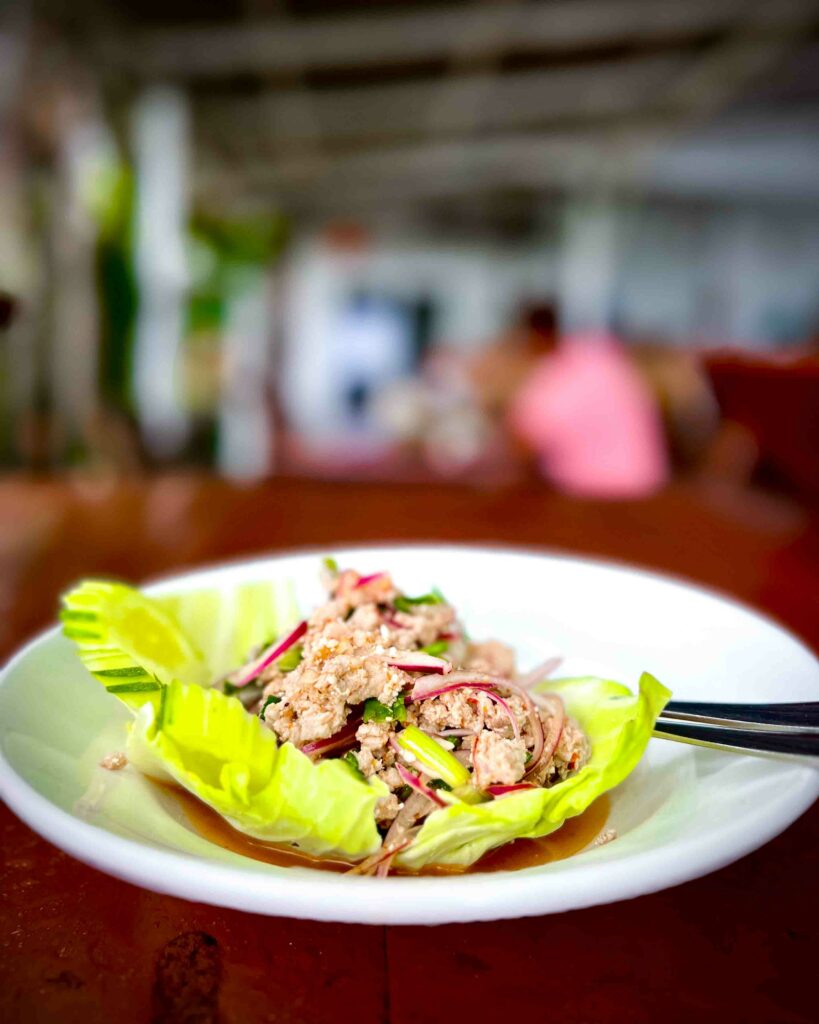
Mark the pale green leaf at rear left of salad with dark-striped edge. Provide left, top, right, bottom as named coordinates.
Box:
left=60, top=580, right=297, bottom=710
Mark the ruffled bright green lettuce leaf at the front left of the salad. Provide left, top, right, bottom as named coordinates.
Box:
left=127, top=682, right=389, bottom=860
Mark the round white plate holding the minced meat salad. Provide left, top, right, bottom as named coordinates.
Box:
left=0, top=546, right=819, bottom=924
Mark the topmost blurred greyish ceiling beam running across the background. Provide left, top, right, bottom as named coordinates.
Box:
left=96, top=0, right=816, bottom=79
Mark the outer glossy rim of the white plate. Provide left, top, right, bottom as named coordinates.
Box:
left=0, top=542, right=819, bottom=925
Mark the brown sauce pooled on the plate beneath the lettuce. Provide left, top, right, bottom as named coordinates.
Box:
left=157, top=783, right=610, bottom=876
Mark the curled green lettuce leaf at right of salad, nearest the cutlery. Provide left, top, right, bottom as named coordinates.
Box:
left=396, top=673, right=671, bottom=869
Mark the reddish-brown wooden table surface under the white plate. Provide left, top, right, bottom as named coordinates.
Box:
left=0, top=476, right=819, bottom=1024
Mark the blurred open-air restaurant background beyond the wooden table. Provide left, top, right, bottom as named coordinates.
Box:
left=0, top=0, right=819, bottom=504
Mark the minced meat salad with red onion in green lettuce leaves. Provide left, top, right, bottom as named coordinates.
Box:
left=61, top=558, right=671, bottom=877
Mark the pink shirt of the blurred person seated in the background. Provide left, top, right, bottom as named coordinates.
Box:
left=509, top=334, right=669, bottom=498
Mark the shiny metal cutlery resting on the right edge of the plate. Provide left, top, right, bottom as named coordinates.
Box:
left=654, top=700, right=819, bottom=767
